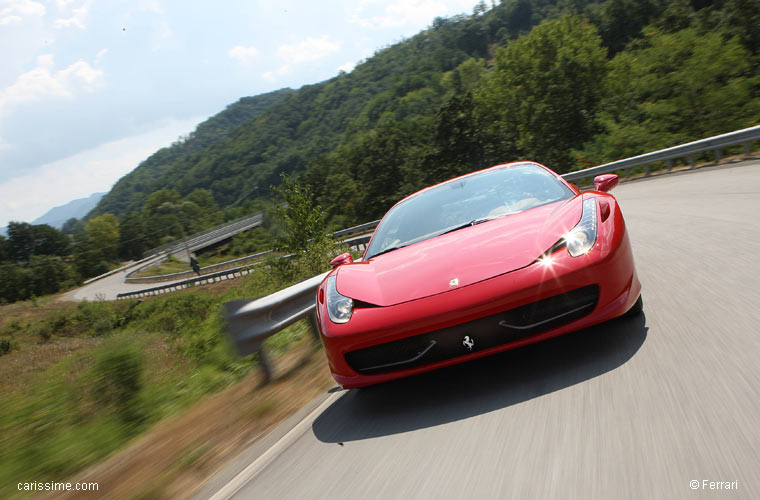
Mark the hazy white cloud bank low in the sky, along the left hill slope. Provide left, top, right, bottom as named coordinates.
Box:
left=0, top=117, right=202, bottom=226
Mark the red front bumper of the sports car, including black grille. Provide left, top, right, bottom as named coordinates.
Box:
left=319, top=225, right=641, bottom=388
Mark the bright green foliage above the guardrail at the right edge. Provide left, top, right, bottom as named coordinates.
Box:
left=582, top=28, right=760, bottom=164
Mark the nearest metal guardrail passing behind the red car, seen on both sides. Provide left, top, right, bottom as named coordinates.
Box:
left=217, top=126, right=760, bottom=379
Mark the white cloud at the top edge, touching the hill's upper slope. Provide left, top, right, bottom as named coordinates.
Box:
left=351, top=0, right=475, bottom=28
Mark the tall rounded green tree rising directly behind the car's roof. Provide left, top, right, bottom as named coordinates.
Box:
left=476, top=15, right=606, bottom=172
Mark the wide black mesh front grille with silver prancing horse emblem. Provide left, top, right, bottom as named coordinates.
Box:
left=346, top=285, right=599, bottom=374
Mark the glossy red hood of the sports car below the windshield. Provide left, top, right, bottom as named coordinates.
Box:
left=336, top=195, right=582, bottom=306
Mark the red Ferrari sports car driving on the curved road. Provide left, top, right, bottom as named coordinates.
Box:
left=317, top=162, right=642, bottom=388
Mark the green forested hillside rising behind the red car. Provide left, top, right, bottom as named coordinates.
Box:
left=92, top=0, right=760, bottom=233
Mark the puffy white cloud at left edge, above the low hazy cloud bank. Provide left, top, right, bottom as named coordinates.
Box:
left=0, top=54, right=104, bottom=115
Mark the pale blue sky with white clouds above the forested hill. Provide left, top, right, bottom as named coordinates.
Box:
left=0, top=0, right=476, bottom=226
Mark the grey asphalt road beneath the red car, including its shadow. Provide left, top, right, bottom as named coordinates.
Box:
left=207, top=162, right=760, bottom=499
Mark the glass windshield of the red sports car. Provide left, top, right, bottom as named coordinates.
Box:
left=365, top=164, right=574, bottom=259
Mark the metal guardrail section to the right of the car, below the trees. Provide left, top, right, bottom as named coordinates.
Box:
left=562, top=125, right=760, bottom=181
